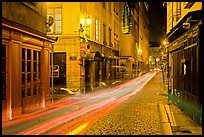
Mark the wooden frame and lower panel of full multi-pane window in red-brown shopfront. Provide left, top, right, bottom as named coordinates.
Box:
left=21, top=46, right=41, bottom=98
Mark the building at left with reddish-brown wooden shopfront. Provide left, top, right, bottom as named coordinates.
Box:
left=2, top=2, right=54, bottom=120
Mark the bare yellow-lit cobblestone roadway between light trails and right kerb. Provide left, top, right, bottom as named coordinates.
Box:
left=85, top=73, right=167, bottom=135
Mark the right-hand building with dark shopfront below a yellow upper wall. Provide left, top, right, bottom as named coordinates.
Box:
left=164, top=2, right=203, bottom=123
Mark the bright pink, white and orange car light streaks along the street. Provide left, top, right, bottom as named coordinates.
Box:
left=4, top=73, right=156, bottom=135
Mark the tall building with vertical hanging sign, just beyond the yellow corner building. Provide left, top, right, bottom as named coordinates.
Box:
left=120, top=2, right=149, bottom=77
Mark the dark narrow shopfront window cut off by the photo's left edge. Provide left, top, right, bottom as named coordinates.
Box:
left=1, top=44, right=7, bottom=100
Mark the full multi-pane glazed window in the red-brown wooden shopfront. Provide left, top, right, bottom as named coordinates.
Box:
left=21, top=48, right=41, bottom=98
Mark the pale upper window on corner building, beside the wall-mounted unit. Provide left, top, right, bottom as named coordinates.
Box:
left=47, top=7, right=62, bottom=34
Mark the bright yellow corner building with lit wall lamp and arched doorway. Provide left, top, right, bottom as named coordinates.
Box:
left=47, top=2, right=120, bottom=91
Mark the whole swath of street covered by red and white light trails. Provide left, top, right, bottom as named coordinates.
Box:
left=2, top=72, right=159, bottom=135
